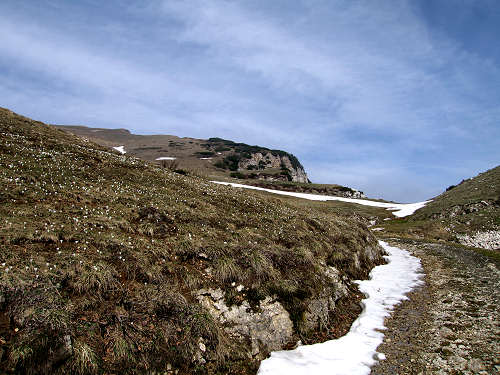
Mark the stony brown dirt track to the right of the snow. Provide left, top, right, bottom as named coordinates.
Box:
left=371, top=240, right=500, bottom=375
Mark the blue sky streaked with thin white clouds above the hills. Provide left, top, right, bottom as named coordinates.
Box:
left=0, top=0, right=500, bottom=202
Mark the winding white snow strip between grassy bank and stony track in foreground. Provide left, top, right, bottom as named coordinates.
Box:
left=258, top=241, right=422, bottom=375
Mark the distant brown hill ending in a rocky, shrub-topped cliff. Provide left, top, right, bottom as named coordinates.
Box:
left=59, top=126, right=309, bottom=183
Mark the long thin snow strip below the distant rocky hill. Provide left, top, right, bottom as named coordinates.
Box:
left=212, top=181, right=430, bottom=217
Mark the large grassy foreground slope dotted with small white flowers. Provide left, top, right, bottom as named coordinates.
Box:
left=0, top=109, right=382, bottom=374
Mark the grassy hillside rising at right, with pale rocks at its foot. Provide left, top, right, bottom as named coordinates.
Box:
left=382, top=166, right=500, bottom=249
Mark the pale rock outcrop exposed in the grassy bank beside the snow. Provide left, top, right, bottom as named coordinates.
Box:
left=194, top=241, right=382, bottom=363
